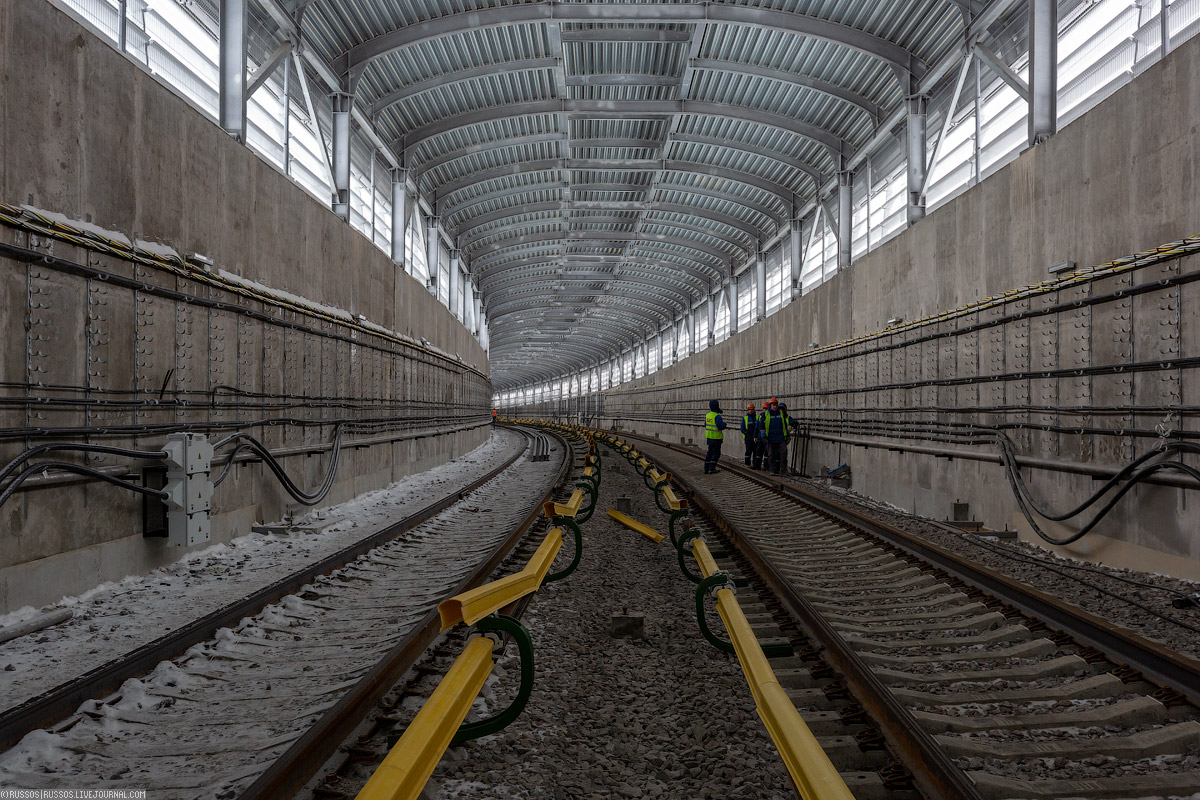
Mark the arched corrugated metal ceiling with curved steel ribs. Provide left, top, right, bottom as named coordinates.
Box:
left=289, top=0, right=982, bottom=390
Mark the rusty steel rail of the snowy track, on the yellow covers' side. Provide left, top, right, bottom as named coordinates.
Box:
left=240, top=426, right=575, bottom=800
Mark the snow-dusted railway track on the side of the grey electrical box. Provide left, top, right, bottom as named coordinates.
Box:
left=0, top=433, right=570, bottom=798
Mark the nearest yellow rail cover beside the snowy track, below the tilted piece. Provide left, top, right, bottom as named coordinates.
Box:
left=356, top=636, right=492, bottom=800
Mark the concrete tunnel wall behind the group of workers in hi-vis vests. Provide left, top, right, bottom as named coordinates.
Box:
left=530, top=32, right=1200, bottom=578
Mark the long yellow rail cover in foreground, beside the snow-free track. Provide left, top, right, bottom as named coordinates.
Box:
left=691, top=539, right=854, bottom=800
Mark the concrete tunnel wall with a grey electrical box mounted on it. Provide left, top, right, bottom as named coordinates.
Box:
left=0, top=2, right=491, bottom=613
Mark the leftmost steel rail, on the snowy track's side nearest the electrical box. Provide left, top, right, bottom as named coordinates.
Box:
left=0, top=431, right=537, bottom=748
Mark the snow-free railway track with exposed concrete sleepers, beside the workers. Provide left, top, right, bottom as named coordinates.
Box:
left=604, top=437, right=1200, bottom=800
